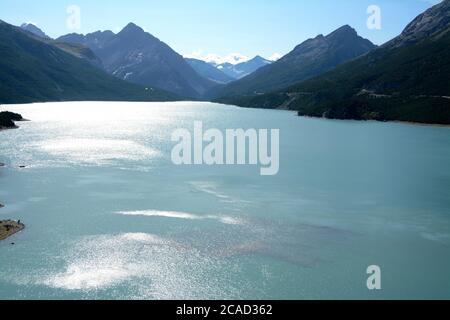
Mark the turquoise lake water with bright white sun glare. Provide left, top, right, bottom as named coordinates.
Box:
left=0, top=102, right=450, bottom=299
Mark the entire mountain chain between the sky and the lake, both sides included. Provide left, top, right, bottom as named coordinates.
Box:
left=0, top=0, right=450, bottom=123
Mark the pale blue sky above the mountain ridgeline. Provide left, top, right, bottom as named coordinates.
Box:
left=0, top=0, right=439, bottom=61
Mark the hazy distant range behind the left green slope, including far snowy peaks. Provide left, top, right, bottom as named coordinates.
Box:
left=12, top=23, right=270, bottom=99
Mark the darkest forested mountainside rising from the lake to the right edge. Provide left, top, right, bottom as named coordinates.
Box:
left=229, top=0, right=450, bottom=124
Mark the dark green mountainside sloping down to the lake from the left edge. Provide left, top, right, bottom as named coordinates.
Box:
left=0, top=20, right=176, bottom=103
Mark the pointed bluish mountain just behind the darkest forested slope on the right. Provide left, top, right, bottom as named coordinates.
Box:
left=214, top=25, right=376, bottom=102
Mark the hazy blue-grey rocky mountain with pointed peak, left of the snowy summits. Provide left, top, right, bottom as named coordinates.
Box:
left=58, top=23, right=216, bottom=99
